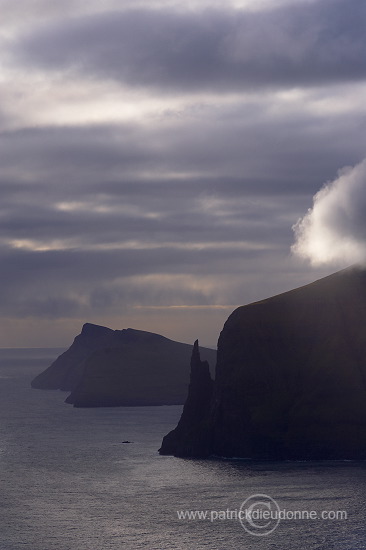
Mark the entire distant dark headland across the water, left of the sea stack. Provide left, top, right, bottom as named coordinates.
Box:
left=32, top=323, right=216, bottom=407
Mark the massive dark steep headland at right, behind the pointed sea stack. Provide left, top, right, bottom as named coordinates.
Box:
left=160, top=269, right=366, bottom=459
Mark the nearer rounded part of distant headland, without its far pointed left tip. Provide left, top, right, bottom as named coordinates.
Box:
left=66, top=329, right=216, bottom=407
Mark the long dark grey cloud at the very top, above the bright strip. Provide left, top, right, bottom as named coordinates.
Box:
left=14, top=0, right=366, bottom=93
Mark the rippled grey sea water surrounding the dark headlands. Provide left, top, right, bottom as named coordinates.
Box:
left=0, top=350, right=366, bottom=550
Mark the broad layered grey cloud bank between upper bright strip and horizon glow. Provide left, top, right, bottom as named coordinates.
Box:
left=0, top=83, right=364, bottom=329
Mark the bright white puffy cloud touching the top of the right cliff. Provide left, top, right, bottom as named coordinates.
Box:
left=292, top=159, right=366, bottom=266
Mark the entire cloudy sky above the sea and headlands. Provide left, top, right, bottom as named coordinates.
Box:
left=0, top=0, right=366, bottom=347
